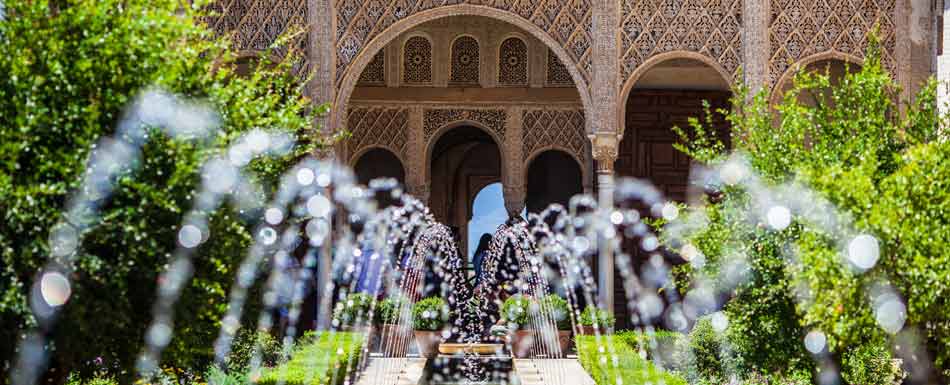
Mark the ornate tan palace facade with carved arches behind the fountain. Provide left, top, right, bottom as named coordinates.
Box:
left=208, top=0, right=944, bottom=322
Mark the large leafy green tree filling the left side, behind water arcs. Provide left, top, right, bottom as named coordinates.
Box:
left=0, top=0, right=325, bottom=380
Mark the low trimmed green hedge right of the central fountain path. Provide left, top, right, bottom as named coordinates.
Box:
left=576, top=334, right=686, bottom=385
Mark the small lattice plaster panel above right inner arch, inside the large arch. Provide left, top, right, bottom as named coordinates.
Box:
left=521, top=109, right=587, bottom=160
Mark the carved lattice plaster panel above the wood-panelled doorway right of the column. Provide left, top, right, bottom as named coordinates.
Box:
left=621, top=0, right=743, bottom=81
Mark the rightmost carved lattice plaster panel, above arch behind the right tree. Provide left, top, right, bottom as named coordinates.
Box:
left=769, top=0, right=897, bottom=85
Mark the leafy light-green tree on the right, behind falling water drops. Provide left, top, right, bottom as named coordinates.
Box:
left=667, top=35, right=950, bottom=383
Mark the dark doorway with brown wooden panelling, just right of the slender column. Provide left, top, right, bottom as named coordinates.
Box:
left=614, top=59, right=731, bottom=329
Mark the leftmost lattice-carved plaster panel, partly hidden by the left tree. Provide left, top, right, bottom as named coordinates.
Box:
left=204, top=0, right=310, bottom=74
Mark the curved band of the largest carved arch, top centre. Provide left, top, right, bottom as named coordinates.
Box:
left=331, top=4, right=592, bottom=132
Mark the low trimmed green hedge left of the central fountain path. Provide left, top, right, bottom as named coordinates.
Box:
left=257, top=332, right=366, bottom=385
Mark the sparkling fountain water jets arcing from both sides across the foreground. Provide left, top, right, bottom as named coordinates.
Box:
left=13, top=92, right=940, bottom=384
